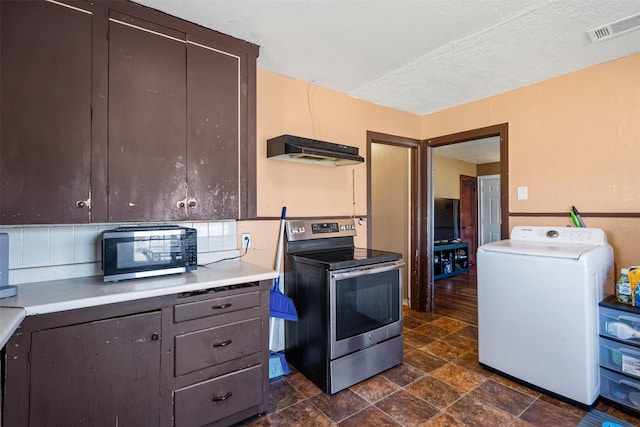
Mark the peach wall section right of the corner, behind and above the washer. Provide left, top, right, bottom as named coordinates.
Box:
left=422, top=54, right=640, bottom=268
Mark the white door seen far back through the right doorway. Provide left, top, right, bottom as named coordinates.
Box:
left=478, top=175, right=501, bottom=246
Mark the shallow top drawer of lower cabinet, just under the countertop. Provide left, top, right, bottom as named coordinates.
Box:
left=173, top=292, right=260, bottom=323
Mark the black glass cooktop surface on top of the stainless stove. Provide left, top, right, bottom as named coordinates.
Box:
left=294, top=248, right=402, bottom=270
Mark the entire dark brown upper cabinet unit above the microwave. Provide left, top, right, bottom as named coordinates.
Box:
left=0, top=0, right=258, bottom=224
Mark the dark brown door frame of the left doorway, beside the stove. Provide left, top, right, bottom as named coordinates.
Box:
left=366, top=131, right=424, bottom=311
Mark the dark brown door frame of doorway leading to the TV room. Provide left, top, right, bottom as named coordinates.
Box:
left=424, top=123, right=509, bottom=312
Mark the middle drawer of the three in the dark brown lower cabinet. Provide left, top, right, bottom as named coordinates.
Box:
left=175, top=317, right=261, bottom=376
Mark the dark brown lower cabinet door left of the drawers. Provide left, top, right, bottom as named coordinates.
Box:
left=29, top=312, right=161, bottom=427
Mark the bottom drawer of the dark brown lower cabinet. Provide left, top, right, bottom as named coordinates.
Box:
left=174, top=365, right=262, bottom=427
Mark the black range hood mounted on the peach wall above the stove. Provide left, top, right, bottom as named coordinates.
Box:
left=267, top=135, right=364, bottom=166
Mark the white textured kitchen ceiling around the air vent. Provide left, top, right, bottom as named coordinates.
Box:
left=131, top=0, right=640, bottom=115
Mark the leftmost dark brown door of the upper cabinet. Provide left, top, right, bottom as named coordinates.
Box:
left=0, top=1, right=92, bottom=224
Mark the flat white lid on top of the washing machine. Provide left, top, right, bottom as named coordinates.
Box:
left=480, top=240, right=597, bottom=260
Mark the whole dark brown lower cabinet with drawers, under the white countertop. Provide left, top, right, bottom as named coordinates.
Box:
left=0, top=281, right=270, bottom=427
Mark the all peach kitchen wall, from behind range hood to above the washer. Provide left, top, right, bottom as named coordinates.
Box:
left=238, top=54, right=640, bottom=274
